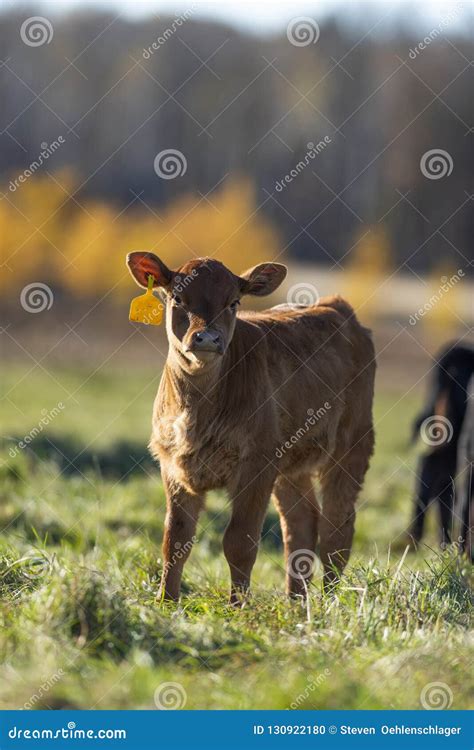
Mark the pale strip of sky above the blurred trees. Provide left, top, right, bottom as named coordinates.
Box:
left=0, top=0, right=474, bottom=33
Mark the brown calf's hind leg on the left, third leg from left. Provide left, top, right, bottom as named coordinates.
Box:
left=273, top=475, right=319, bottom=598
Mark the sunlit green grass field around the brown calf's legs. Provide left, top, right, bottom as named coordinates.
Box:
left=0, top=367, right=472, bottom=709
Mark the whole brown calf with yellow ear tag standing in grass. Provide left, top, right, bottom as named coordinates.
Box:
left=127, top=252, right=375, bottom=603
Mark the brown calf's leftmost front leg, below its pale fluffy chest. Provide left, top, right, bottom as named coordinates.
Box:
left=157, top=471, right=203, bottom=600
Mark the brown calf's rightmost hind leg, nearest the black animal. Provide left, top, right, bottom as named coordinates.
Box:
left=320, top=429, right=374, bottom=588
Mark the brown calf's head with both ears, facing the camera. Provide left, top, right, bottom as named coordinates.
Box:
left=127, top=252, right=286, bottom=369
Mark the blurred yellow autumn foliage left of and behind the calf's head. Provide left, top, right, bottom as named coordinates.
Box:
left=0, top=171, right=280, bottom=297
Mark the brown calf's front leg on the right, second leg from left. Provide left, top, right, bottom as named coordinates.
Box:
left=224, top=466, right=276, bottom=605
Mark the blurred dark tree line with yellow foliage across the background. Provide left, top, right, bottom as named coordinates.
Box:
left=0, top=8, right=474, bottom=296
